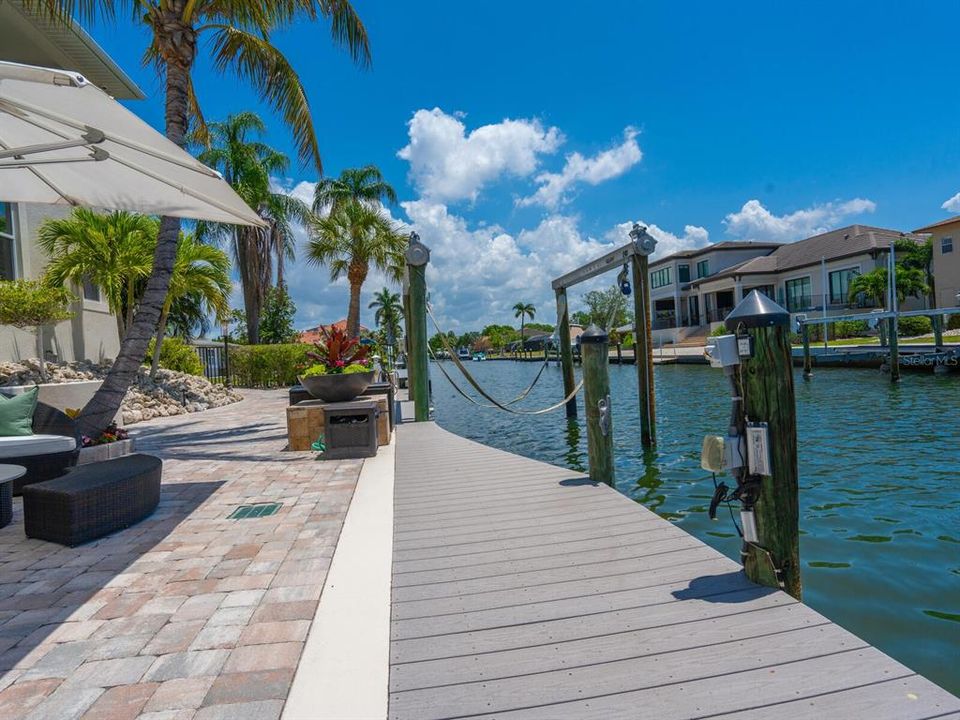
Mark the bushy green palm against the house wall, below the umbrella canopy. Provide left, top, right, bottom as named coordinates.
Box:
left=37, top=208, right=159, bottom=341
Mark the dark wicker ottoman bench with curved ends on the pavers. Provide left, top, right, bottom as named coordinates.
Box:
left=23, top=454, right=163, bottom=547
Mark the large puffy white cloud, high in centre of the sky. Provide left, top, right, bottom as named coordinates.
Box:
left=397, top=108, right=563, bottom=201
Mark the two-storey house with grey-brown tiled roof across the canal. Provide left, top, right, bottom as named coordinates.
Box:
left=650, top=225, right=923, bottom=342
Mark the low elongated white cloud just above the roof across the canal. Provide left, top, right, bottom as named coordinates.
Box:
left=723, top=198, right=877, bottom=242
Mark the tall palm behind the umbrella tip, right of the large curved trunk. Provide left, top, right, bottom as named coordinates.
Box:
left=194, top=112, right=311, bottom=344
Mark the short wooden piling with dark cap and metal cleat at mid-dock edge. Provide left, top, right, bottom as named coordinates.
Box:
left=580, top=325, right=614, bottom=487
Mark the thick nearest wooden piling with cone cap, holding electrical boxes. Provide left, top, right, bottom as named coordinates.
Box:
left=726, top=291, right=802, bottom=600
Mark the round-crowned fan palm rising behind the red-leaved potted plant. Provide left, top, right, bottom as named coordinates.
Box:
left=307, top=202, right=406, bottom=337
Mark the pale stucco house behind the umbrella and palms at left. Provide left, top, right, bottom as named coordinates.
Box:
left=0, top=0, right=143, bottom=361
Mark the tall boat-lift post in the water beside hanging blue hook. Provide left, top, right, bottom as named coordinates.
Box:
left=630, top=223, right=657, bottom=448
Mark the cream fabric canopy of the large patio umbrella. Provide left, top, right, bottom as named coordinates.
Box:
left=0, top=62, right=265, bottom=226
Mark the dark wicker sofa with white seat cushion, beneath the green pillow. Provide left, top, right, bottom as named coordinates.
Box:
left=0, top=403, right=80, bottom=495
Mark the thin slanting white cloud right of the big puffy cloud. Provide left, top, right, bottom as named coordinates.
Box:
left=517, top=127, right=643, bottom=209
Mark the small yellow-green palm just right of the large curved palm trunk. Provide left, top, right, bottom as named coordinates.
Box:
left=150, top=233, right=232, bottom=378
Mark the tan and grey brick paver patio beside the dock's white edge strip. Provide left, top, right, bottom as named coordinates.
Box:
left=0, top=391, right=362, bottom=720
